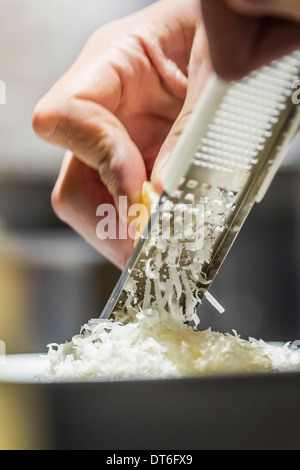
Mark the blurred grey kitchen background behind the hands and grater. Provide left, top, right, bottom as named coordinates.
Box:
left=0, top=0, right=300, bottom=353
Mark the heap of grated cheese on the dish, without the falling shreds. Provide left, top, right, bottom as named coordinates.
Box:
left=39, top=310, right=300, bottom=382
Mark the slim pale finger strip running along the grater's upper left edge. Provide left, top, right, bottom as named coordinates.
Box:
left=151, top=25, right=212, bottom=193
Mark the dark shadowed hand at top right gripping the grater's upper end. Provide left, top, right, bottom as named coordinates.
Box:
left=202, top=0, right=300, bottom=80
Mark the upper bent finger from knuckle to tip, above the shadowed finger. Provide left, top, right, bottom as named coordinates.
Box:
left=34, top=96, right=146, bottom=213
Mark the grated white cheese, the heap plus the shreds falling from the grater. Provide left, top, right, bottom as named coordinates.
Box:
left=39, top=187, right=300, bottom=381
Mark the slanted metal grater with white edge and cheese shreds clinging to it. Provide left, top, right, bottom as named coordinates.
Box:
left=100, top=52, right=300, bottom=324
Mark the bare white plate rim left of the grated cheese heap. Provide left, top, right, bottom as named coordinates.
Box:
left=0, top=354, right=48, bottom=383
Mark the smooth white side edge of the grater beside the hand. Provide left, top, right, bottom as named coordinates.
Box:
left=162, top=74, right=230, bottom=195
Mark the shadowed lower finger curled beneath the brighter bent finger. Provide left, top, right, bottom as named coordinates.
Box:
left=52, top=152, right=133, bottom=269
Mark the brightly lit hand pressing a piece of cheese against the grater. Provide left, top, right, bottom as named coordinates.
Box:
left=33, top=0, right=211, bottom=268
